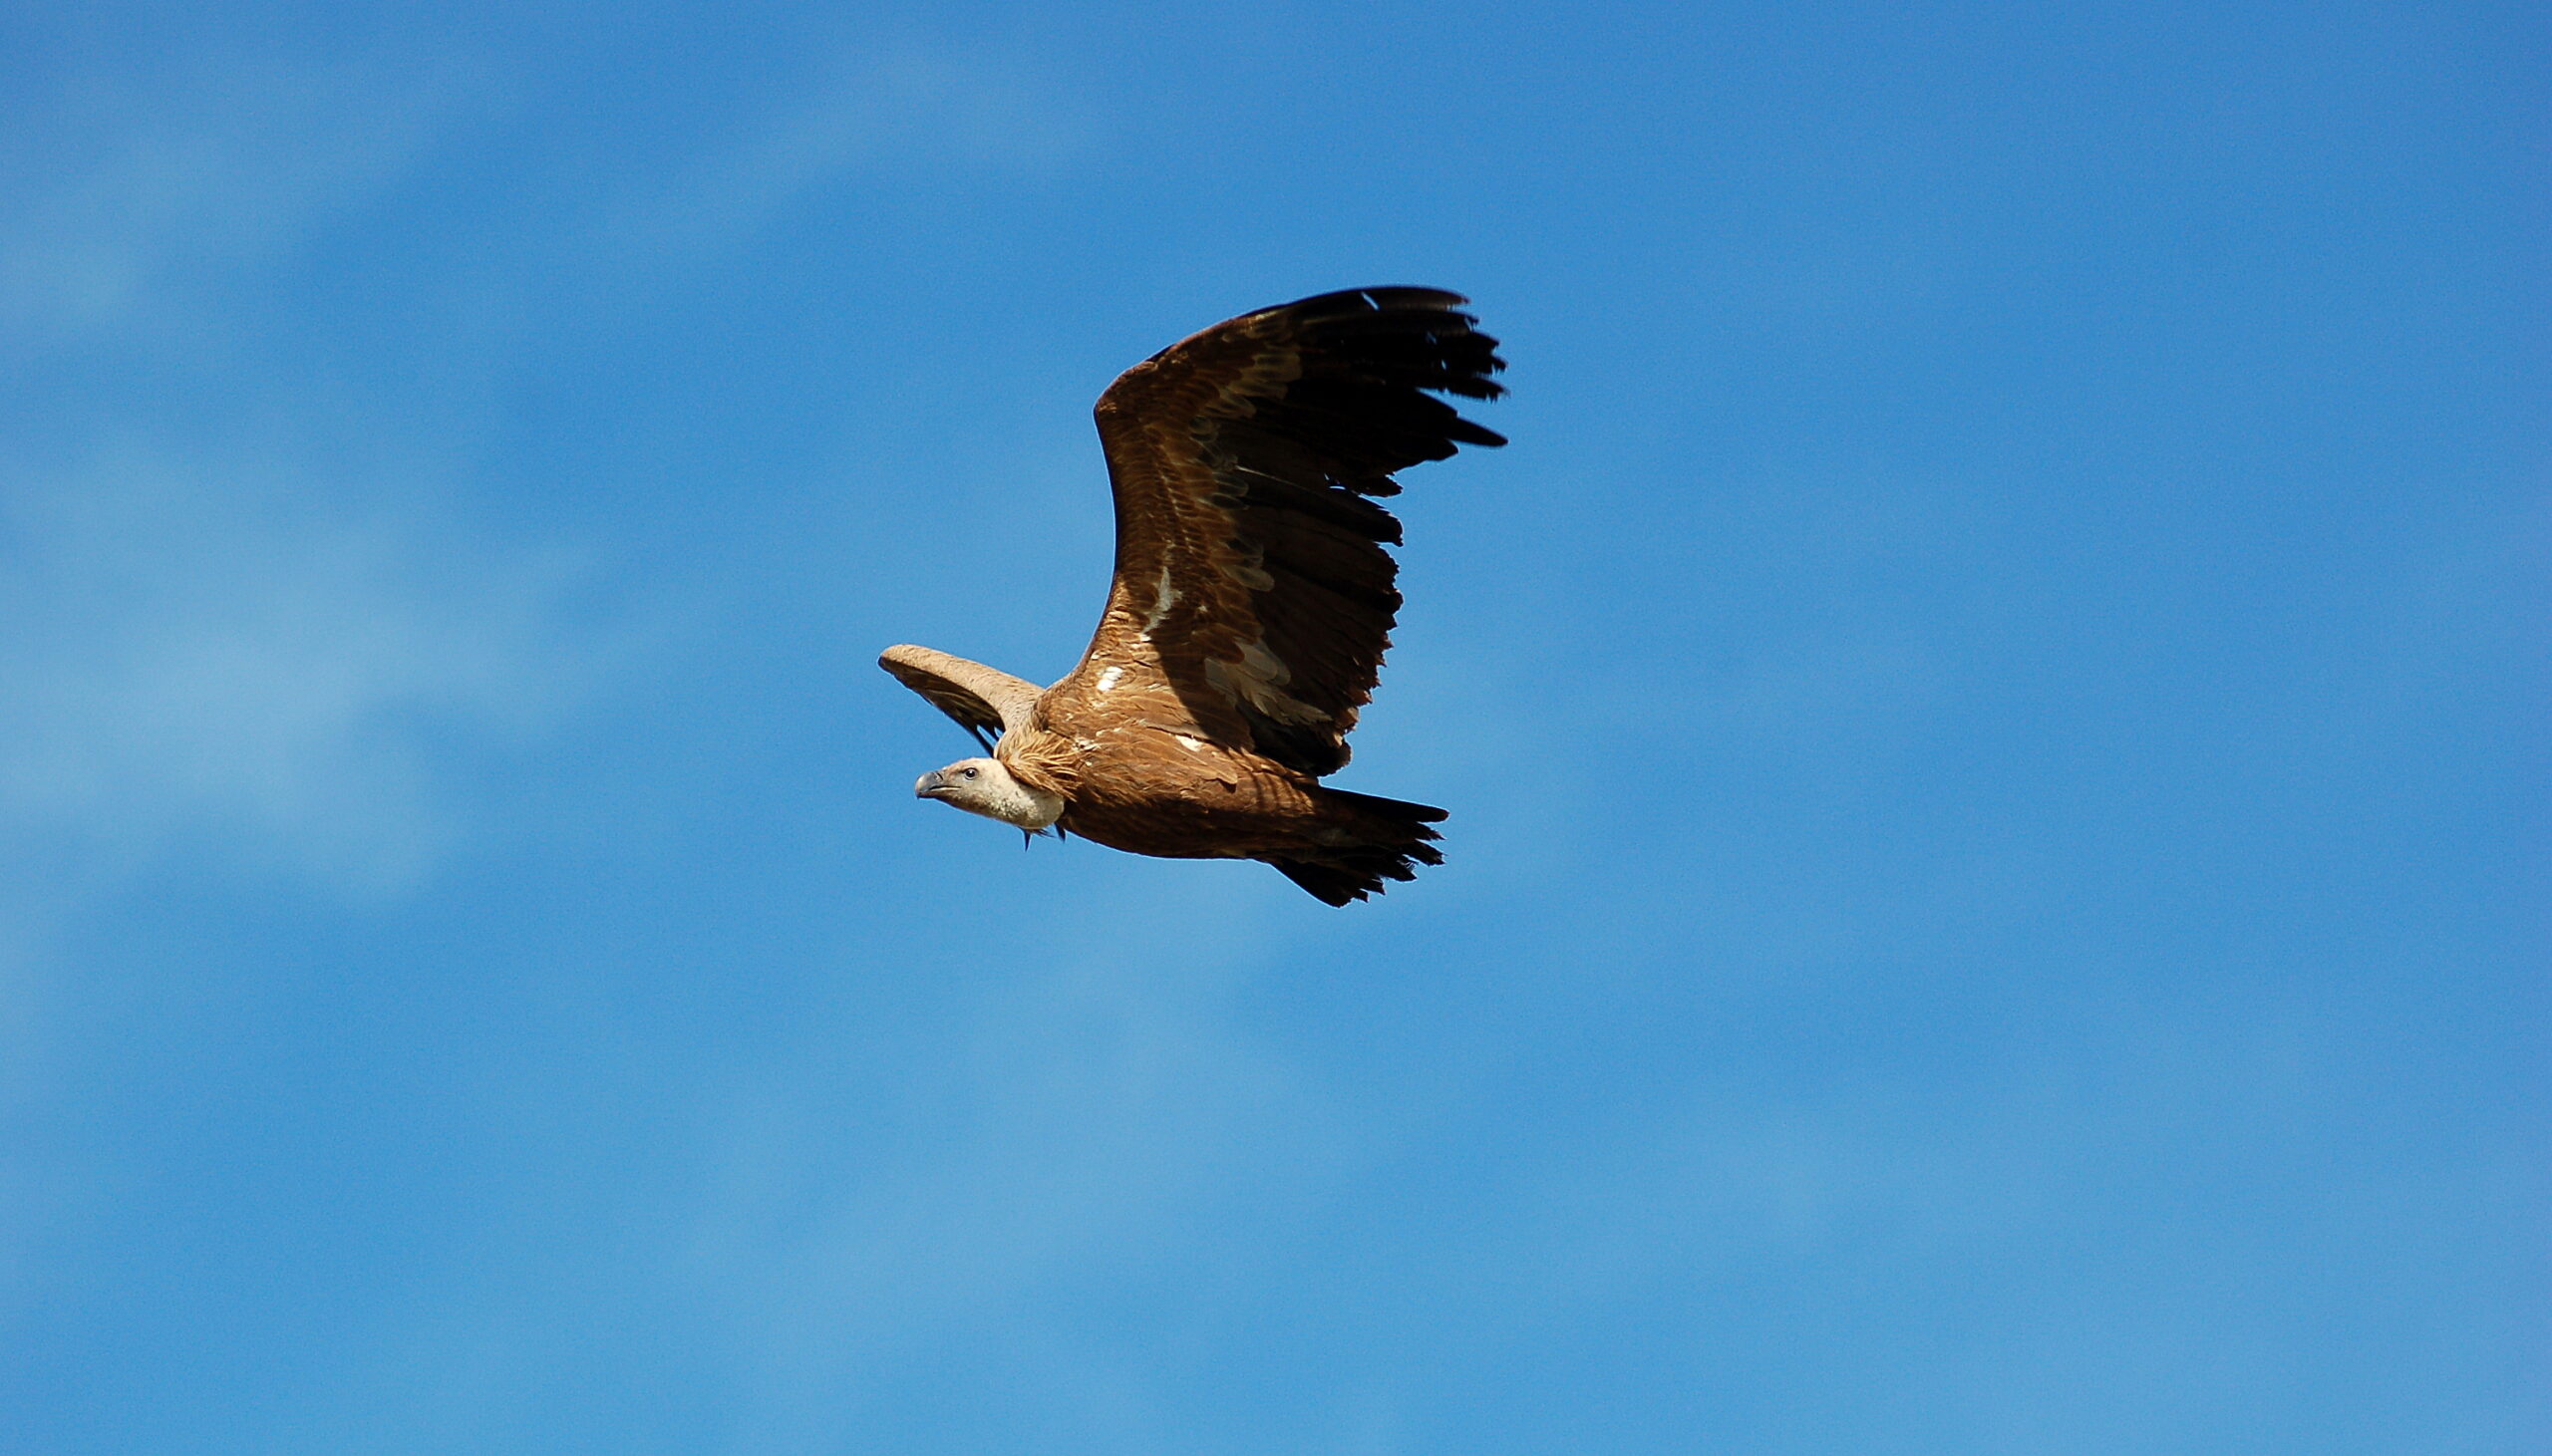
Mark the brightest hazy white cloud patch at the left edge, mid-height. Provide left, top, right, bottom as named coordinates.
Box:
left=0, top=446, right=584, bottom=890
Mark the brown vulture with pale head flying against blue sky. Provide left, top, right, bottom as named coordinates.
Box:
left=878, top=288, right=1505, bottom=905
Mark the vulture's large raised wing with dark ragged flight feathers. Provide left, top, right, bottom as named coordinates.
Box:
left=1054, top=288, right=1505, bottom=775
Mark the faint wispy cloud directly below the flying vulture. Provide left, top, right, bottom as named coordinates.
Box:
left=669, top=882, right=1337, bottom=1446
